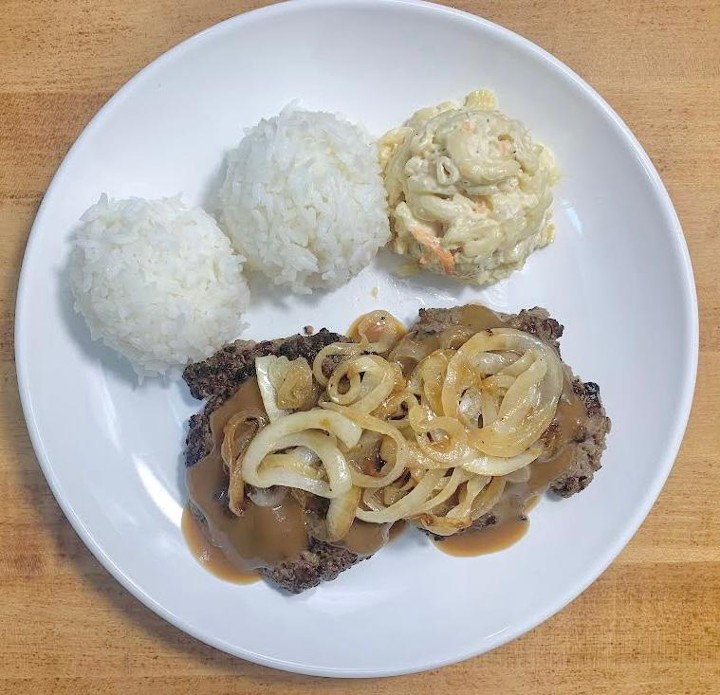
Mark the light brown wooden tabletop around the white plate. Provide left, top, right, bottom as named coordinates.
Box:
left=0, top=0, right=720, bottom=695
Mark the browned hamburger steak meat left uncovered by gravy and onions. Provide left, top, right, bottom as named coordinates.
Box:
left=183, top=307, right=610, bottom=593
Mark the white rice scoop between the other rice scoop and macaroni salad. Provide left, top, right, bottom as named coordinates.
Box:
left=219, top=106, right=390, bottom=293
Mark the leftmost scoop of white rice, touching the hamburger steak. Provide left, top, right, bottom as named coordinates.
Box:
left=70, top=195, right=249, bottom=377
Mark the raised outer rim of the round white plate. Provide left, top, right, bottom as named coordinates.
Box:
left=14, top=0, right=699, bottom=678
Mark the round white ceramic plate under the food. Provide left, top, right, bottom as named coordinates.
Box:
left=16, top=0, right=697, bottom=676
